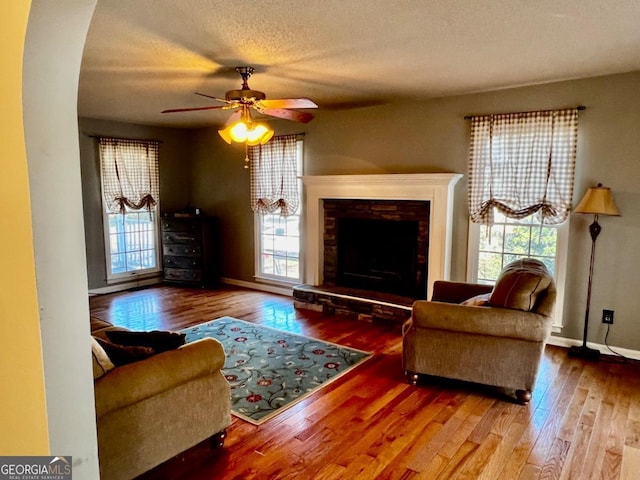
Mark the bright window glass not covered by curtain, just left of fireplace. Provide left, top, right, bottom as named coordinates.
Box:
left=255, top=140, right=303, bottom=282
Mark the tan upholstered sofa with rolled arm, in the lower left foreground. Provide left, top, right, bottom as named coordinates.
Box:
left=91, top=318, right=231, bottom=480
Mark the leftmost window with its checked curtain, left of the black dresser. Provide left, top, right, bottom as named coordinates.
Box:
left=99, top=138, right=160, bottom=282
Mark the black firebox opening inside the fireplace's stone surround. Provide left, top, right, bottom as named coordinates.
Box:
left=336, top=217, right=420, bottom=297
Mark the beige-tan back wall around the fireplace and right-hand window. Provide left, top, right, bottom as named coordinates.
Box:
left=192, top=72, right=640, bottom=350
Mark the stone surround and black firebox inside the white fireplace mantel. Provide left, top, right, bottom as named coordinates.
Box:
left=323, top=199, right=429, bottom=299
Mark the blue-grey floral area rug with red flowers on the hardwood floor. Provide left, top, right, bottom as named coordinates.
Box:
left=182, top=317, right=372, bottom=425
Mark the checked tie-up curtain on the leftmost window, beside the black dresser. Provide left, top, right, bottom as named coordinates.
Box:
left=98, top=138, right=160, bottom=213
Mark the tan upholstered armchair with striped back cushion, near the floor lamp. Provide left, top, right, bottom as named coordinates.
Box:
left=403, top=259, right=556, bottom=404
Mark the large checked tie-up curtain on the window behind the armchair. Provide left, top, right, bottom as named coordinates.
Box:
left=468, top=108, right=578, bottom=225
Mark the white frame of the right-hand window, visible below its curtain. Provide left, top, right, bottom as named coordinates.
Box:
left=467, top=219, right=570, bottom=333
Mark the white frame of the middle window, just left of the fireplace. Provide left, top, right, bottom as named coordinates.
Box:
left=253, top=138, right=305, bottom=285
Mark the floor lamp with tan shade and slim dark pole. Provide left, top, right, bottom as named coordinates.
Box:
left=569, top=183, right=620, bottom=360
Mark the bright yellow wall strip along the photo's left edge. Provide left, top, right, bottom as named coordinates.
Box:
left=0, top=0, right=49, bottom=455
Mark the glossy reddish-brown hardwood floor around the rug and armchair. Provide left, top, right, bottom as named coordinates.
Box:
left=90, top=286, right=640, bottom=480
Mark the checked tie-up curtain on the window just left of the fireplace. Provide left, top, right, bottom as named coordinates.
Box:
left=249, top=135, right=300, bottom=217
